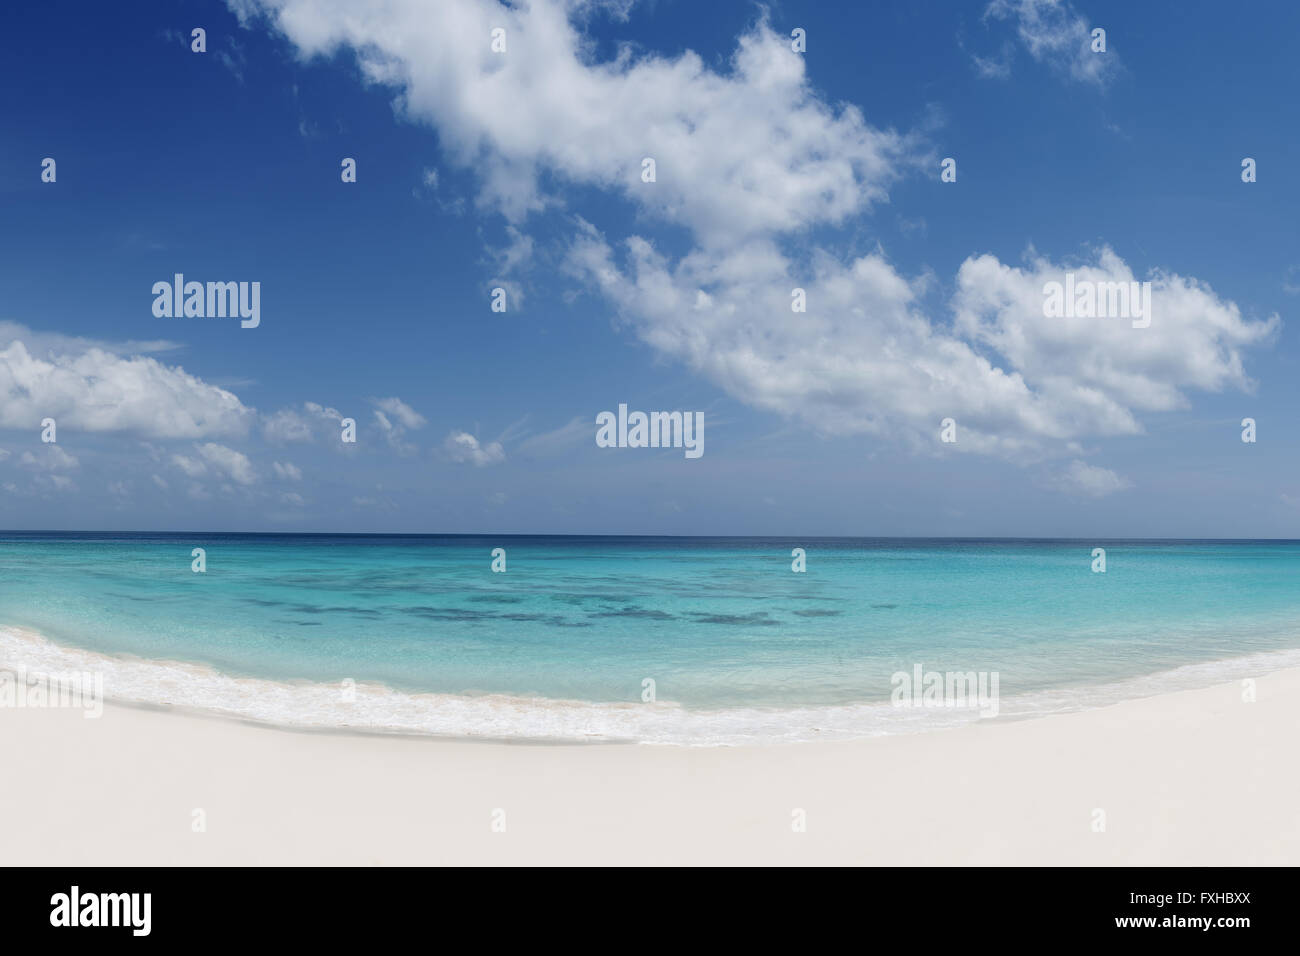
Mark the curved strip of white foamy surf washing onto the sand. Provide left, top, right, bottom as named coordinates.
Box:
left=0, top=626, right=1300, bottom=749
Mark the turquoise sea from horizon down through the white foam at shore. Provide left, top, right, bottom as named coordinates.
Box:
left=0, top=532, right=1300, bottom=743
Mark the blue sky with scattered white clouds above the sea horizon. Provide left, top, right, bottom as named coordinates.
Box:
left=0, top=0, right=1300, bottom=537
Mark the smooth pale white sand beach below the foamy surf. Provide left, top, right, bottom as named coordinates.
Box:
left=0, top=669, right=1300, bottom=866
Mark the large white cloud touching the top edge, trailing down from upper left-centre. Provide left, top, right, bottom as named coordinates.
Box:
left=230, top=0, right=904, bottom=239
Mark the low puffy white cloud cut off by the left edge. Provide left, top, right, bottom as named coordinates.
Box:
left=0, top=323, right=255, bottom=438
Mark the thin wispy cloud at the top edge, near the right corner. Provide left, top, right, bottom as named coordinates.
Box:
left=976, top=0, right=1119, bottom=87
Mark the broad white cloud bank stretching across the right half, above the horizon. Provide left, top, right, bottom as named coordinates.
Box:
left=571, top=230, right=1278, bottom=458
